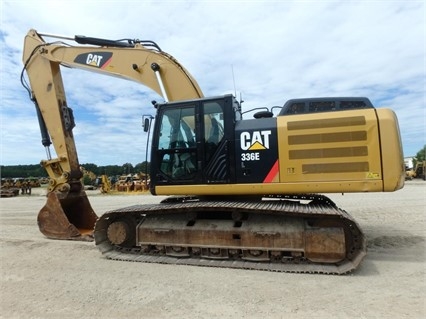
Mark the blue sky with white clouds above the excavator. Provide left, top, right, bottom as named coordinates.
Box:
left=0, top=0, right=426, bottom=165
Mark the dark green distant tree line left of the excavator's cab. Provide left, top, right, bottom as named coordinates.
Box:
left=0, top=162, right=149, bottom=178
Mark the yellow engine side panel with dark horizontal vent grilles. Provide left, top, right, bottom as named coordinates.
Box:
left=277, top=109, right=383, bottom=191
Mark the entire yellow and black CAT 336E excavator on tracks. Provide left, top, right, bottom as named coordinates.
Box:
left=21, top=30, right=405, bottom=274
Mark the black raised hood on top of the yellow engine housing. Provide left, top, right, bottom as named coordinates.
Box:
left=278, top=97, right=374, bottom=116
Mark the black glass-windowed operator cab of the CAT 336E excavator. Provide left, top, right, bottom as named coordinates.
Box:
left=151, top=94, right=241, bottom=191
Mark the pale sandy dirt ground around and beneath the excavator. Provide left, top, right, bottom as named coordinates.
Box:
left=0, top=180, right=426, bottom=319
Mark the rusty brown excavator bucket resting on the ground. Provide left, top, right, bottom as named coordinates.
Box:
left=37, top=191, right=98, bottom=241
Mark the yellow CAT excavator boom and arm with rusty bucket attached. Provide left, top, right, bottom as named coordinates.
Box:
left=21, top=30, right=203, bottom=240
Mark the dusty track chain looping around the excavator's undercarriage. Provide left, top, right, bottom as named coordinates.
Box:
left=94, top=195, right=366, bottom=275
